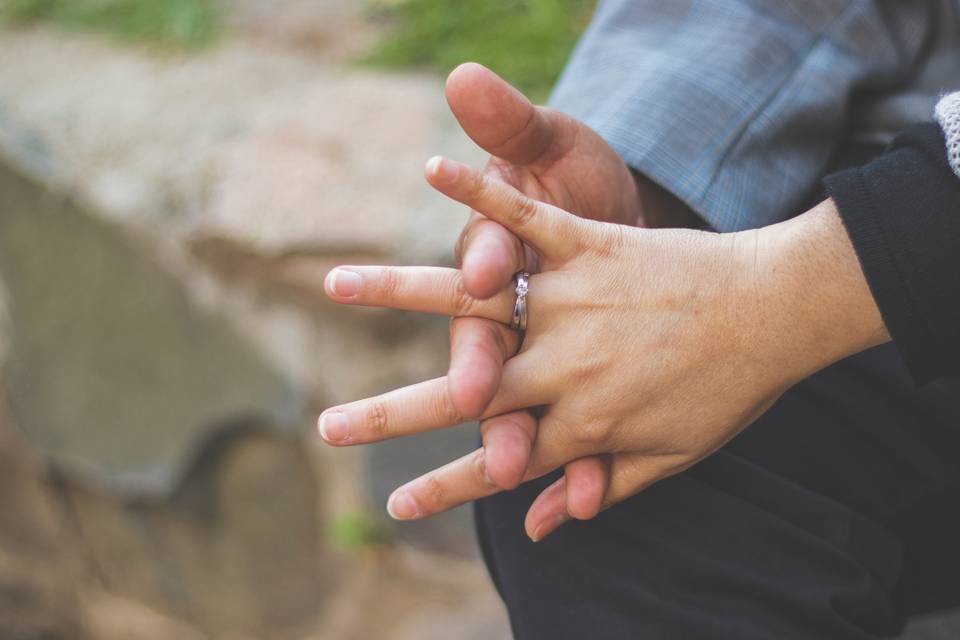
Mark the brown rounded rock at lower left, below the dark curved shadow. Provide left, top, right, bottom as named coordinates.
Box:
left=61, top=422, right=337, bottom=638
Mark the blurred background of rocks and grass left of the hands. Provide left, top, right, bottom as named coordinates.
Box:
left=0, top=0, right=592, bottom=640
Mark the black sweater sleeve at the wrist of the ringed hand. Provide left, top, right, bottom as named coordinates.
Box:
left=824, top=123, right=960, bottom=384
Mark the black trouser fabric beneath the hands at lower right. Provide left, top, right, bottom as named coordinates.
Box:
left=475, top=345, right=960, bottom=640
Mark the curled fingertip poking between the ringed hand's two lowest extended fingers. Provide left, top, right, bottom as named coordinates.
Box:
left=480, top=411, right=537, bottom=490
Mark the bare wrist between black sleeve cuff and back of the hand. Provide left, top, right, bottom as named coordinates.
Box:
left=755, top=200, right=890, bottom=381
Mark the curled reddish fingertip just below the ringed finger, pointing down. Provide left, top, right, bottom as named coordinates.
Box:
left=447, top=317, right=520, bottom=416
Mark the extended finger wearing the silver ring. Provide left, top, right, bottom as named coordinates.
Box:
left=324, top=266, right=516, bottom=324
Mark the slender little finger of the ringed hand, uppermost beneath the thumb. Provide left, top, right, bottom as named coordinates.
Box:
left=425, top=156, right=583, bottom=259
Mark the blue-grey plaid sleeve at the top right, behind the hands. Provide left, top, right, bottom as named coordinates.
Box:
left=551, top=0, right=931, bottom=231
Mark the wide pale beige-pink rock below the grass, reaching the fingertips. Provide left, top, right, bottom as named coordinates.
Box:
left=0, top=26, right=483, bottom=272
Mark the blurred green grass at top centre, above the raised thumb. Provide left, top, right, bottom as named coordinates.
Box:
left=363, top=0, right=596, bottom=101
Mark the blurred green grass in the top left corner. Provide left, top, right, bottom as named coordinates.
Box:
left=0, top=0, right=219, bottom=49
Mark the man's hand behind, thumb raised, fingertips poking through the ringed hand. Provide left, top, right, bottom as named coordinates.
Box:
left=446, top=63, right=653, bottom=518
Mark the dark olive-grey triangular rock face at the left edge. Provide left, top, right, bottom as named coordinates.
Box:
left=0, top=162, right=304, bottom=491
